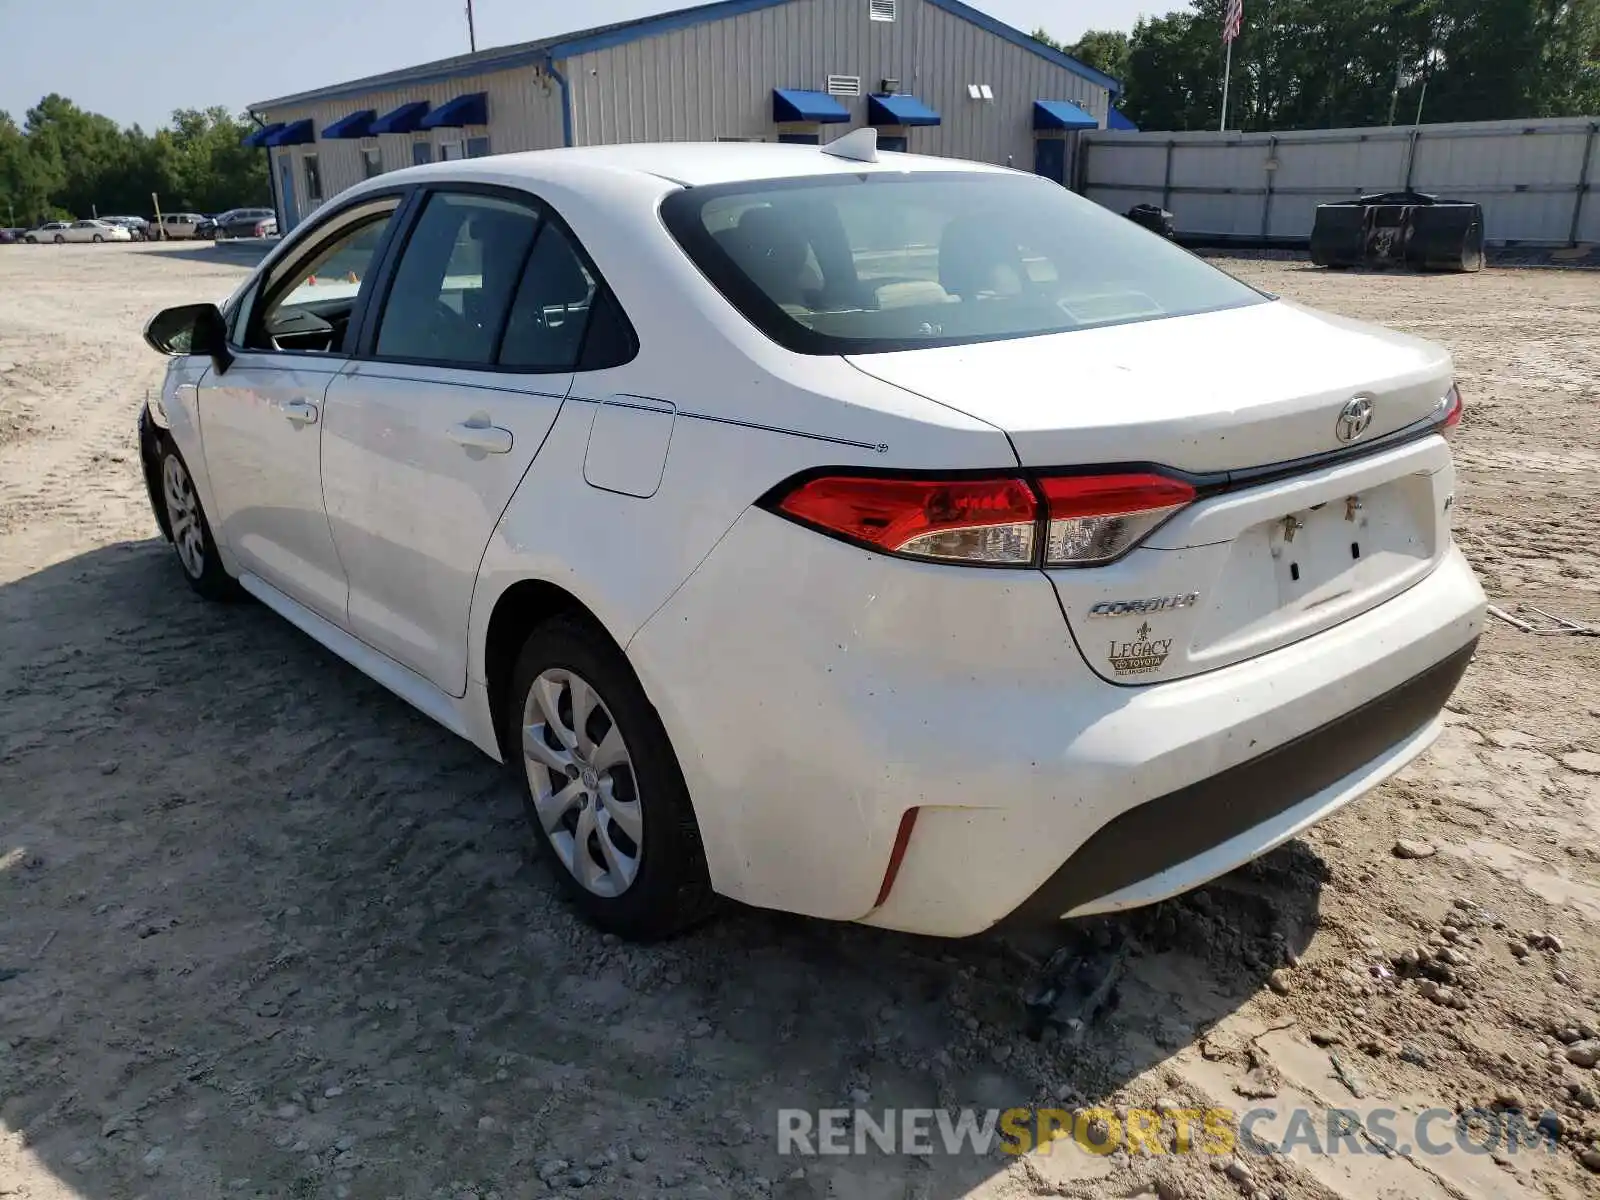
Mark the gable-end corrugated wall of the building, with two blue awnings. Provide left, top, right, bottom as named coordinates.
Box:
left=566, top=0, right=1109, bottom=170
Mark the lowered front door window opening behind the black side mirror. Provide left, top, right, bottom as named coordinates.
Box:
left=243, top=198, right=398, bottom=354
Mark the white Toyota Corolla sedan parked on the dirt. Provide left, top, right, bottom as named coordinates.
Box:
left=139, top=131, right=1485, bottom=938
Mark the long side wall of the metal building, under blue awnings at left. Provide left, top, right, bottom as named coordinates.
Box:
left=261, top=67, right=562, bottom=221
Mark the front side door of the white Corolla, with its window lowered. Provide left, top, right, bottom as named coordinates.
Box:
left=200, top=194, right=402, bottom=626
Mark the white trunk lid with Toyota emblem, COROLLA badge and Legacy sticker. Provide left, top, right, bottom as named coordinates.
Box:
left=851, top=302, right=1454, bottom=685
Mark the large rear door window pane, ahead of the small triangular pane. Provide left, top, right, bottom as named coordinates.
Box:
left=378, top=192, right=541, bottom=366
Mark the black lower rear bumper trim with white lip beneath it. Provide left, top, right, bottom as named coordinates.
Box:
left=1011, top=638, right=1477, bottom=922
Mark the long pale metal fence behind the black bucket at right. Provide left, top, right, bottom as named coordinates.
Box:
left=1085, top=117, right=1600, bottom=245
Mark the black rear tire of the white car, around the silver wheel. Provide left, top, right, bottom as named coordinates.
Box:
left=504, top=614, right=717, bottom=941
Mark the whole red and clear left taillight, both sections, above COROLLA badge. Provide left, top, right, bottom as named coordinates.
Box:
left=773, top=474, right=1195, bottom=566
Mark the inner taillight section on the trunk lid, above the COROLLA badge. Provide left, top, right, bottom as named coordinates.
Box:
left=1038, top=474, right=1195, bottom=566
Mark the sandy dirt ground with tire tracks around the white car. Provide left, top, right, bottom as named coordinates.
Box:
left=0, top=246, right=1600, bottom=1200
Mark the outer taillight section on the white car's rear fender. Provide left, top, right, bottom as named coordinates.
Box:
left=778, top=475, right=1038, bottom=566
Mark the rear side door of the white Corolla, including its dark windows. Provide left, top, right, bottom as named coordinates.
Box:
left=323, top=184, right=600, bottom=696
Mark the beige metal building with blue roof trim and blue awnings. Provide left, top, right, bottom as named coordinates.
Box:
left=246, top=0, right=1120, bottom=232
